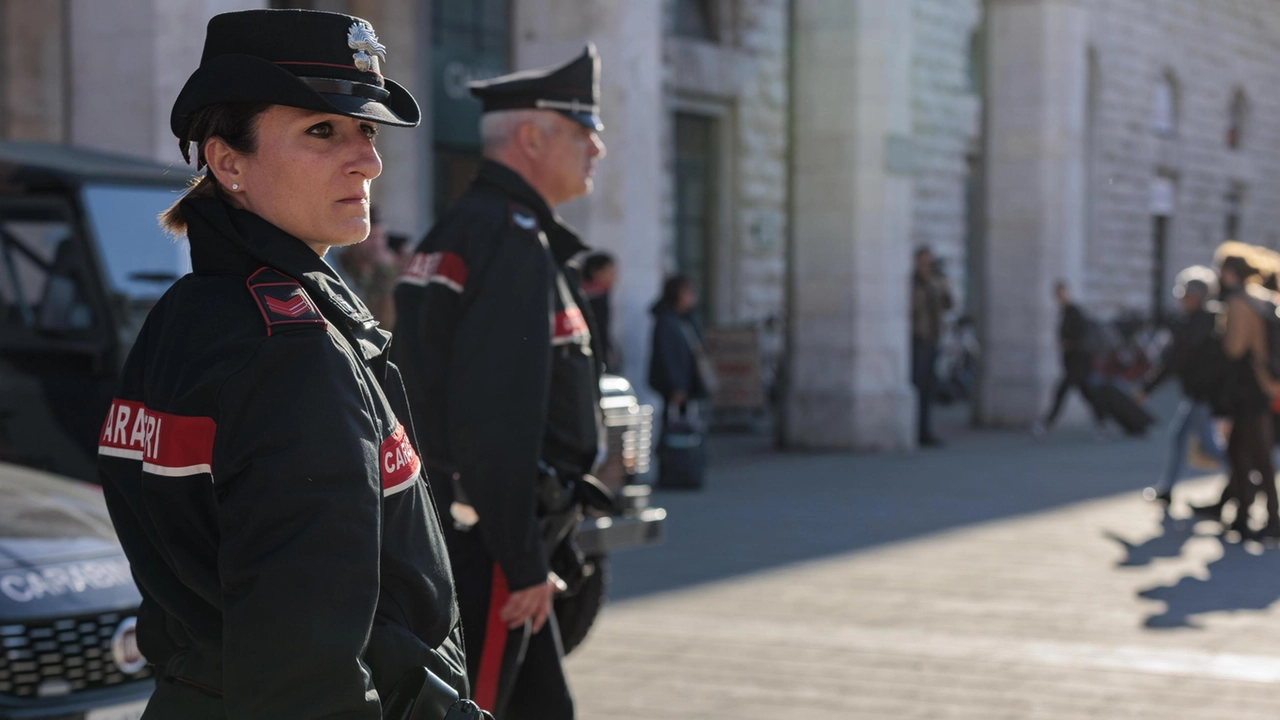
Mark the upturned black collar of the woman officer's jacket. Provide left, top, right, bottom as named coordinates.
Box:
left=182, top=197, right=392, bottom=360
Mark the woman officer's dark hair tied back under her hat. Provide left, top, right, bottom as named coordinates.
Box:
left=160, top=102, right=271, bottom=237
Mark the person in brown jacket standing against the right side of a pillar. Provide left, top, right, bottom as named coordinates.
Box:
left=911, top=247, right=952, bottom=447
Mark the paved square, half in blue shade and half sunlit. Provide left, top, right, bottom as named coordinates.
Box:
left=568, top=407, right=1280, bottom=720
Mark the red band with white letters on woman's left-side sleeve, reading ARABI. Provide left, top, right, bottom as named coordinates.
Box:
left=97, top=400, right=218, bottom=478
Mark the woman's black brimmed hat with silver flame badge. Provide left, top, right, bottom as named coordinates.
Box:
left=169, top=10, right=421, bottom=140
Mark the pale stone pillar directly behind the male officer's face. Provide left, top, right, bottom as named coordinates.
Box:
left=512, top=0, right=666, bottom=392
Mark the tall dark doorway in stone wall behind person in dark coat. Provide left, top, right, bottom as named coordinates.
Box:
left=673, top=113, right=717, bottom=322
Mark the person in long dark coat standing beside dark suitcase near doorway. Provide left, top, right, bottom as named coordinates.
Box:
left=649, top=275, right=716, bottom=487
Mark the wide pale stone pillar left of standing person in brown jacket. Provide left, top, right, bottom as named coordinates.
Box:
left=783, top=0, right=915, bottom=450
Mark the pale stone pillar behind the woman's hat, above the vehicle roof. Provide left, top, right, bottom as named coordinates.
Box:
left=69, top=0, right=266, bottom=164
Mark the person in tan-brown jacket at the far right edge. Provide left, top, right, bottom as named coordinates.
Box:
left=1193, top=242, right=1280, bottom=539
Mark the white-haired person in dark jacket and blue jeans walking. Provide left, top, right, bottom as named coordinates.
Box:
left=1138, top=265, right=1226, bottom=505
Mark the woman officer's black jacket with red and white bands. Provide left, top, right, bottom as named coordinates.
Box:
left=99, top=199, right=466, bottom=720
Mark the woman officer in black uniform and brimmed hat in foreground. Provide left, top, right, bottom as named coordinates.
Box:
left=99, top=10, right=474, bottom=720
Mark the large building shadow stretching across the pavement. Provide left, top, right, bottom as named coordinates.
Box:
left=611, top=397, right=1165, bottom=600
